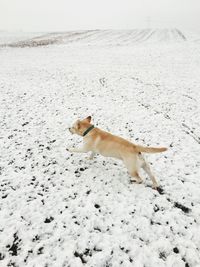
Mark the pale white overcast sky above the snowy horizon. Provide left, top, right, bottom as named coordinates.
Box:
left=0, top=0, right=200, bottom=31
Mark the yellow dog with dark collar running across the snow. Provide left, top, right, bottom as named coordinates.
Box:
left=67, top=116, right=167, bottom=189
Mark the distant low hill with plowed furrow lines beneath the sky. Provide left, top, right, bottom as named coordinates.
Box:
left=0, top=29, right=200, bottom=47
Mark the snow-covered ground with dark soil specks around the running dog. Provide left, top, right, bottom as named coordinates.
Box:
left=0, top=32, right=200, bottom=267
